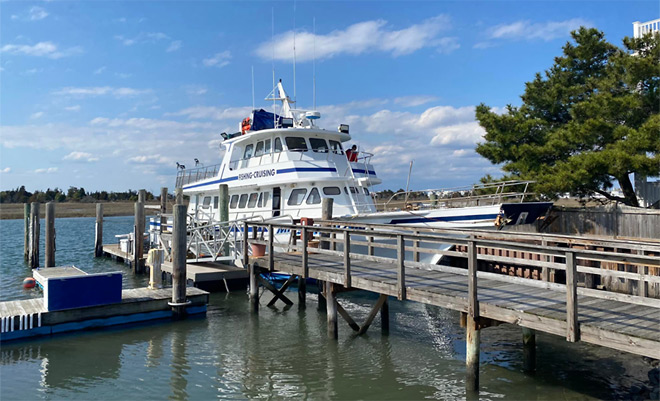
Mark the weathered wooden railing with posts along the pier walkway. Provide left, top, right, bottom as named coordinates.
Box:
left=244, top=220, right=660, bottom=356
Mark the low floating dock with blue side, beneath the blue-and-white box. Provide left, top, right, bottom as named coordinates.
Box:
left=0, top=287, right=209, bottom=341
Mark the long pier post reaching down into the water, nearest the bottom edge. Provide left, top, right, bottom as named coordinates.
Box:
left=465, top=241, right=480, bottom=391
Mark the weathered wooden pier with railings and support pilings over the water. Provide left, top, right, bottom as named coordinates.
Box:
left=244, top=221, right=660, bottom=390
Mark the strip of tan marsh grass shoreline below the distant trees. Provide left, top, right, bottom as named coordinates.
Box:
left=0, top=201, right=165, bottom=220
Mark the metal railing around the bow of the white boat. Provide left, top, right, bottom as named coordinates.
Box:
left=378, top=180, right=534, bottom=210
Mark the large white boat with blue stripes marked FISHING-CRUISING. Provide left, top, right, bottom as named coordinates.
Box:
left=150, top=81, right=551, bottom=264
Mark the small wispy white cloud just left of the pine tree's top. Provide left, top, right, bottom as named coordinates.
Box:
left=489, top=18, right=593, bottom=41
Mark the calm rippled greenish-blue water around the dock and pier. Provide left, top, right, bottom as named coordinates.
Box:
left=0, top=217, right=650, bottom=400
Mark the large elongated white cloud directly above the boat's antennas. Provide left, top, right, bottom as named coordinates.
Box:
left=256, top=15, right=458, bottom=61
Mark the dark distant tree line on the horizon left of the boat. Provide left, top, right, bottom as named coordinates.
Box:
left=0, top=186, right=155, bottom=203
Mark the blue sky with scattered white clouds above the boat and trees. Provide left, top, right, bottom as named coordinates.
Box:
left=0, top=0, right=660, bottom=192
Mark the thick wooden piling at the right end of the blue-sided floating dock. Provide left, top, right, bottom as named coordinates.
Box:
left=171, top=205, right=188, bottom=319
